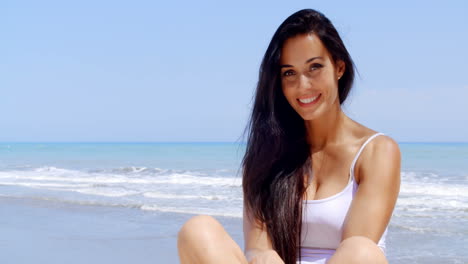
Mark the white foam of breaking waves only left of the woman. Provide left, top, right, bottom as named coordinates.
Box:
left=0, top=166, right=242, bottom=215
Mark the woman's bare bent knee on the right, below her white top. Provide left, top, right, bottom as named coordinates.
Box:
left=327, top=236, right=388, bottom=264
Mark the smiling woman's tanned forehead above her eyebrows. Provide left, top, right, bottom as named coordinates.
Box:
left=280, top=34, right=328, bottom=66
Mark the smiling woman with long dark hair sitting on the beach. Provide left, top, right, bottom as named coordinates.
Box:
left=178, top=9, right=400, bottom=264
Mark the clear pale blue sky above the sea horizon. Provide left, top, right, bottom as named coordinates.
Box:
left=0, top=0, right=468, bottom=142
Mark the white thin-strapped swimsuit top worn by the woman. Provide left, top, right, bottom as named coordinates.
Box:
left=297, top=133, right=387, bottom=264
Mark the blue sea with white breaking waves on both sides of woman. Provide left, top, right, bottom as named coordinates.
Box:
left=0, top=142, right=468, bottom=263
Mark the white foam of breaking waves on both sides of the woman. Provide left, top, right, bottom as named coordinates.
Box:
left=0, top=166, right=468, bottom=221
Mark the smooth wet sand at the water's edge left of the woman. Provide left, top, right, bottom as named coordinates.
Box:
left=0, top=198, right=243, bottom=264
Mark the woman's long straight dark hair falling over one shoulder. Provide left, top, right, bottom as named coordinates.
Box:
left=242, top=9, right=354, bottom=264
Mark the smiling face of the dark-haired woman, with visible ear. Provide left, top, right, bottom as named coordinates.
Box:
left=280, top=34, right=344, bottom=120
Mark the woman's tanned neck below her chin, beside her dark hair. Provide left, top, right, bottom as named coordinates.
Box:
left=305, top=100, right=347, bottom=153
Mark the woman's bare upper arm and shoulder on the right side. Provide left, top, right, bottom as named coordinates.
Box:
left=342, top=136, right=401, bottom=243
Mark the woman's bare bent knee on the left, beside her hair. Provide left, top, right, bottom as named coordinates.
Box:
left=177, top=215, right=247, bottom=264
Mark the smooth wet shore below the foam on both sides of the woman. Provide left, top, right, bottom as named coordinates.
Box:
left=0, top=197, right=468, bottom=264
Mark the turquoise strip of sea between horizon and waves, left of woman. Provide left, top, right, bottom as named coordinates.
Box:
left=0, top=143, right=244, bottom=169
